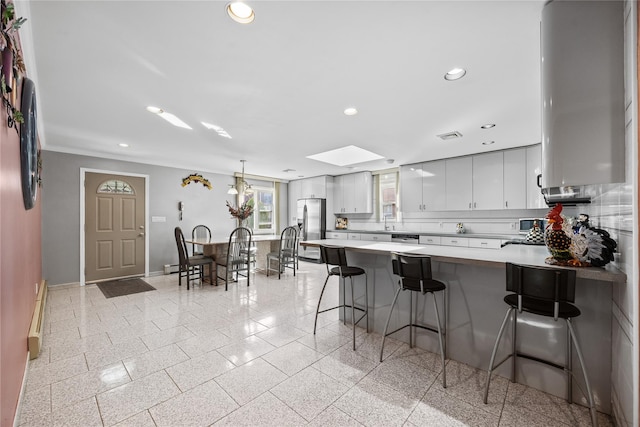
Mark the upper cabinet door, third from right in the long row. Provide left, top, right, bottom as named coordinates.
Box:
left=472, top=151, right=504, bottom=210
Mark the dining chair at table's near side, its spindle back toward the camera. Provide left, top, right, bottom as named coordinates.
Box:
left=216, top=227, right=253, bottom=291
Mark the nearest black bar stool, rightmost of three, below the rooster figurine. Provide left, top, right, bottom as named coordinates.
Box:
left=484, top=263, right=598, bottom=426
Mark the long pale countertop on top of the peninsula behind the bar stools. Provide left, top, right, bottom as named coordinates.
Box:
left=300, top=239, right=627, bottom=283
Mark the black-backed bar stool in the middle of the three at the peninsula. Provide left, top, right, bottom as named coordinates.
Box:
left=380, top=252, right=447, bottom=388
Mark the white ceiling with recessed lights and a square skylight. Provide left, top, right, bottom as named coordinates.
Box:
left=16, top=0, right=544, bottom=179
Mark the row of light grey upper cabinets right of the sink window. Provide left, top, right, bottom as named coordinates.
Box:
left=400, top=144, right=545, bottom=214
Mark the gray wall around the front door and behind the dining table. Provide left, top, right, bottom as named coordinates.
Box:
left=41, top=150, right=287, bottom=285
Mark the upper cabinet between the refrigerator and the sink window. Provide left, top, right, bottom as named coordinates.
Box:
left=333, top=172, right=373, bottom=214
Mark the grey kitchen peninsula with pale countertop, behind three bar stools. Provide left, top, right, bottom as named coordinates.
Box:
left=301, top=239, right=626, bottom=413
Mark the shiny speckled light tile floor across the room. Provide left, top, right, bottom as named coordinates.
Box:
left=19, top=262, right=611, bottom=427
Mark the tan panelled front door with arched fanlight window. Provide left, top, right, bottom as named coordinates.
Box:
left=85, top=172, right=145, bottom=283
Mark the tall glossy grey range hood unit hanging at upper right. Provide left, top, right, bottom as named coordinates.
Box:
left=538, top=0, right=625, bottom=206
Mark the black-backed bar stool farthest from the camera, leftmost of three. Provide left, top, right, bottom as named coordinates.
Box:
left=313, top=245, right=369, bottom=350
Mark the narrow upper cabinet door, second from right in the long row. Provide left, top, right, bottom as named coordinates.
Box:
left=502, top=148, right=527, bottom=209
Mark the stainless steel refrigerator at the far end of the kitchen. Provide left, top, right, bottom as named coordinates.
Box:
left=297, top=199, right=327, bottom=262
